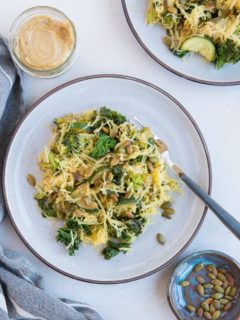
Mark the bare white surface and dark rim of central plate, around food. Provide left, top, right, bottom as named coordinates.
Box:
left=4, top=75, right=211, bottom=283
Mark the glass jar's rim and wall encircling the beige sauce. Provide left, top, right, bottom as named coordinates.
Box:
left=10, top=6, right=78, bottom=78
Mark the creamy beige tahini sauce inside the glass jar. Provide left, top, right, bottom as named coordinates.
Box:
left=16, top=16, right=75, bottom=70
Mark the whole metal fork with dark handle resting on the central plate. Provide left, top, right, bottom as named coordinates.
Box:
left=131, top=117, right=240, bottom=239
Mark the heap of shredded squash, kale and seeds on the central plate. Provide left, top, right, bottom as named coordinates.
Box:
left=35, top=107, right=179, bottom=259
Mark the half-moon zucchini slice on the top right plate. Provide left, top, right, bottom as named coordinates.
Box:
left=181, top=36, right=216, bottom=61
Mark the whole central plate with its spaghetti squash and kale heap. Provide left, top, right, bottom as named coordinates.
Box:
left=3, top=75, right=211, bottom=283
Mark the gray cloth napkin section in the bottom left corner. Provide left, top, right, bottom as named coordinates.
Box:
left=0, top=247, right=103, bottom=320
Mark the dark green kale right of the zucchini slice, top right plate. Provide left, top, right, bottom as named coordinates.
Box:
left=214, top=39, right=240, bottom=69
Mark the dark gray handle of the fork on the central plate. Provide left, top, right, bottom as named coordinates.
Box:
left=178, top=172, right=240, bottom=239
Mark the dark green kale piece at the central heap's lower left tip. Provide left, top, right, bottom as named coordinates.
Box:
left=56, top=228, right=81, bottom=256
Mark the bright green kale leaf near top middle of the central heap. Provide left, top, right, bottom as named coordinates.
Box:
left=90, top=132, right=117, bottom=159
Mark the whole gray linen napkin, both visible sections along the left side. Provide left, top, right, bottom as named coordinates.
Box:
left=0, top=36, right=102, bottom=320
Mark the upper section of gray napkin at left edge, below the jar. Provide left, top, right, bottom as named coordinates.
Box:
left=0, top=36, right=25, bottom=221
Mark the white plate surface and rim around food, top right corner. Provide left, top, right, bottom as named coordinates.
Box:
left=122, top=0, right=240, bottom=85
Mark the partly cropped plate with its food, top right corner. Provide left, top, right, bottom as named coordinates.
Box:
left=122, top=0, right=240, bottom=85
